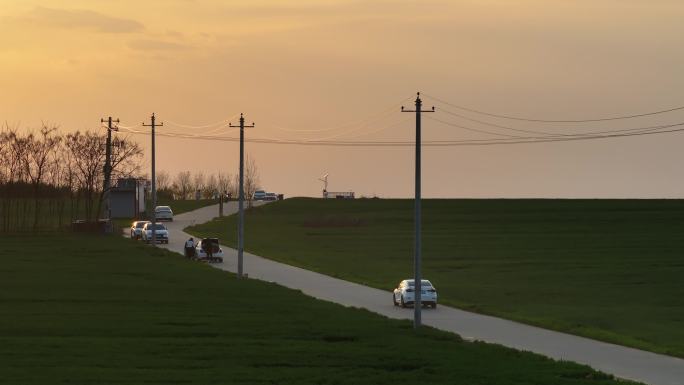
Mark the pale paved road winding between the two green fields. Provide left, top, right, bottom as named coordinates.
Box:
left=148, top=202, right=684, bottom=385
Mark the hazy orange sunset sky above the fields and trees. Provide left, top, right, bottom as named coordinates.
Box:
left=0, top=0, right=684, bottom=198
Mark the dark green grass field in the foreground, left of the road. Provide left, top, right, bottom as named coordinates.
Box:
left=0, top=234, right=622, bottom=385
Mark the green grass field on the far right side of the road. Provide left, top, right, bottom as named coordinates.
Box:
left=184, top=199, right=684, bottom=357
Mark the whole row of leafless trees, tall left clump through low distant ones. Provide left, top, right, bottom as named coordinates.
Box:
left=0, top=124, right=259, bottom=231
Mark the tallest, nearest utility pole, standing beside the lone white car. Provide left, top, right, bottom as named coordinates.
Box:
left=401, top=92, right=435, bottom=329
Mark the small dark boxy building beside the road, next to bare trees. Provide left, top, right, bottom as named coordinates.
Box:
left=110, top=178, right=149, bottom=218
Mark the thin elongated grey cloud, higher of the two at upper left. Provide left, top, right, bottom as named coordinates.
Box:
left=26, top=7, right=145, bottom=33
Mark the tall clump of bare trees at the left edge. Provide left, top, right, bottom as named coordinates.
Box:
left=0, top=124, right=143, bottom=231
